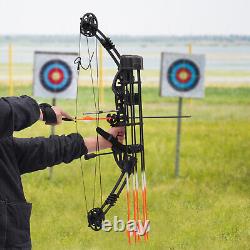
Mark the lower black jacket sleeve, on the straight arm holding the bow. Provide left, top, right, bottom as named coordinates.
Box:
left=13, top=133, right=88, bottom=174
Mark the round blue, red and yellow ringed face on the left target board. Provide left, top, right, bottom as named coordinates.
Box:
left=39, top=60, right=72, bottom=93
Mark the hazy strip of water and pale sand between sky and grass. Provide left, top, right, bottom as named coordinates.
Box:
left=0, top=35, right=250, bottom=87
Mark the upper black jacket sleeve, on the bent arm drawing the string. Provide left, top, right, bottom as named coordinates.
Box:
left=0, top=96, right=40, bottom=138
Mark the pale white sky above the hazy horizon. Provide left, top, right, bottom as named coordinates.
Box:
left=0, top=0, right=250, bottom=36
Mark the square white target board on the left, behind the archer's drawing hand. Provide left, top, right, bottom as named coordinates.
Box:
left=34, top=52, right=77, bottom=98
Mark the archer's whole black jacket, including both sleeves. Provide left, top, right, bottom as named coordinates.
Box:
left=0, top=96, right=87, bottom=250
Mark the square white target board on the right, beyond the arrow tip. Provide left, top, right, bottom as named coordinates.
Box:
left=161, top=53, right=205, bottom=98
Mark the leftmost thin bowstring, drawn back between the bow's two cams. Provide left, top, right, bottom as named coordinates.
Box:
left=75, top=33, right=88, bottom=214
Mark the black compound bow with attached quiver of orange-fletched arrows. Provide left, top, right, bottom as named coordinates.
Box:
left=77, top=13, right=147, bottom=238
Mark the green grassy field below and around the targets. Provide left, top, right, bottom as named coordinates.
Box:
left=0, top=87, right=250, bottom=250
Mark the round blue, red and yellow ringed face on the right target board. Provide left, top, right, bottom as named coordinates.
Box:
left=167, top=59, right=200, bottom=91
